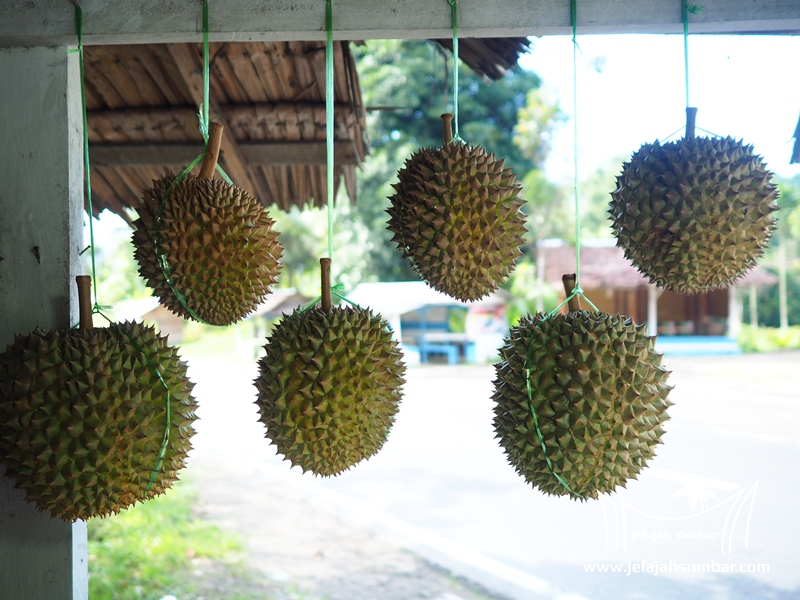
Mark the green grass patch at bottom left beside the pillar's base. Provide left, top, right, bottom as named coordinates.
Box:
left=88, top=482, right=280, bottom=600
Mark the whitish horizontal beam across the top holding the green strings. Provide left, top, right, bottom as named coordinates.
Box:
left=0, top=0, right=800, bottom=46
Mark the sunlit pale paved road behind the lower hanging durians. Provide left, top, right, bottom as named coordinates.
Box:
left=184, top=353, right=800, bottom=600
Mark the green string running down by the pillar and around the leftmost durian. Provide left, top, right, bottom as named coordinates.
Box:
left=75, top=4, right=172, bottom=493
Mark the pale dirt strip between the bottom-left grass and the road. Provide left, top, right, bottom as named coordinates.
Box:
left=192, top=461, right=504, bottom=600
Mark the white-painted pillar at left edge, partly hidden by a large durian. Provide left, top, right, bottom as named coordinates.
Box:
left=0, top=46, right=89, bottom=600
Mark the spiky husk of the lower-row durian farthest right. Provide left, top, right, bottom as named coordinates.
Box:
left=492, top=311, right=672, bottom=499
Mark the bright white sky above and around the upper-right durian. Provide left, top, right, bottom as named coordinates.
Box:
left=520, top=32, right=800, bottom=181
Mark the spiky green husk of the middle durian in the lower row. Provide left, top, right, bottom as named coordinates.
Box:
left=256, top=307, right=405, bottom=476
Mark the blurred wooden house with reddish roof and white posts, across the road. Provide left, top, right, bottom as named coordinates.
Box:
left=537, top=240, right=778, bottom=337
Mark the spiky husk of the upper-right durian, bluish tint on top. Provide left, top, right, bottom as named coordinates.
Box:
left=609, top=137, right=778, bottom=294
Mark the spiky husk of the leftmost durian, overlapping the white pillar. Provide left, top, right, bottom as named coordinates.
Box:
left=0, top=323, right=197, bottom=521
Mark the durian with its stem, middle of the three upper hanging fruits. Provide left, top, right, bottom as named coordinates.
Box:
left=386, top=114, right=525, bottom=301
